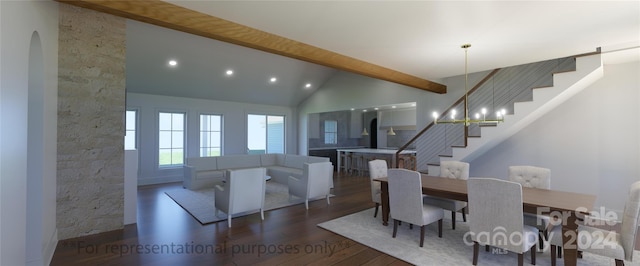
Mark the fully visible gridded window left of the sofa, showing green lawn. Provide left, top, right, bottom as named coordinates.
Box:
left=158, top=112, right=185, bottom=167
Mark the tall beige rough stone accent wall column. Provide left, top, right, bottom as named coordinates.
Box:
left=56, top=3, right=126, bottom=240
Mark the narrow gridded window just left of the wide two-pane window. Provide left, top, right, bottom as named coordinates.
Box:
left=200, top=115, right=222, bottom=157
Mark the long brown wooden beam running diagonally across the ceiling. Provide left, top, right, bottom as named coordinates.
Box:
left=57, top=0, right=447, bottom=93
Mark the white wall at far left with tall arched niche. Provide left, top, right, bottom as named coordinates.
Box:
left=0, top=1, right=58, bottom=265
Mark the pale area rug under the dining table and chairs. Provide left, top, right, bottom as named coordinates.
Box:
left=318, top=209, right=640, bottom=266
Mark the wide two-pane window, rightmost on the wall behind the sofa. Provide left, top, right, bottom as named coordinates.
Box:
left=247, top=114, right=284, bottom=154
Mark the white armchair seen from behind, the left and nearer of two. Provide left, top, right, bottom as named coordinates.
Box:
left=214, top=168, right=266, bottom=227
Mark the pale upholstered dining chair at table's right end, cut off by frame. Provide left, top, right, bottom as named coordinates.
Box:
left=549, top=181, right=640, bottom=266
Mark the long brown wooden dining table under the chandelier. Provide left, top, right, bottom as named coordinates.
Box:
left=373, top=174, right=596, bottom=266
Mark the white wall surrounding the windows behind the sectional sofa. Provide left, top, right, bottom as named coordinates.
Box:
left=127, top=93, right=297, bottom=185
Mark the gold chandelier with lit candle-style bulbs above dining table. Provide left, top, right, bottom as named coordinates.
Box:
left=433, top=44, right=507, bottom=126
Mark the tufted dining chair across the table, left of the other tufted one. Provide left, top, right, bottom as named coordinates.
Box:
left=424, top=161, right=469, bottom=230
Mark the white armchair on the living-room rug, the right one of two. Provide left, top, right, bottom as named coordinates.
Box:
left=289, top=162, right=333, bottom=210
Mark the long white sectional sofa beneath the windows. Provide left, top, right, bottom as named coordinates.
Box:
left=183, top=154, right=329, bottom=190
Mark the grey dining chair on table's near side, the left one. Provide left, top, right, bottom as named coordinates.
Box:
left=387, top=168, right=444, bottom=247
